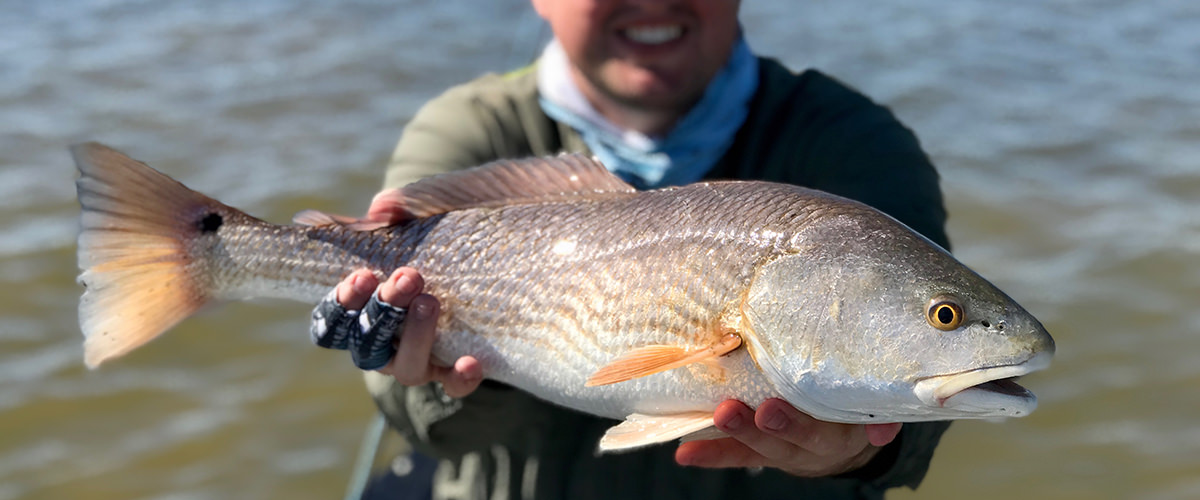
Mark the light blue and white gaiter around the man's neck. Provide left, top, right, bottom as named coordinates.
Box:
left=538, top=38, right=758, bottom=189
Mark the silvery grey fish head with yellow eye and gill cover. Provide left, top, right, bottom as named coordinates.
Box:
left=743, top=200, right=1055, bottom=422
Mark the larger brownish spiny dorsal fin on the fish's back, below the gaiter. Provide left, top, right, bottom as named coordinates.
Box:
left=393, top=153, right=636, bottom=217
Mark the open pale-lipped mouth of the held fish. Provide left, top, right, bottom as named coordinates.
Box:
left=916, top=353, right=1050, bottom=406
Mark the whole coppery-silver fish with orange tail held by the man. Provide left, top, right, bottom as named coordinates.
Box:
left=73, top=144, right=1055, bottom=450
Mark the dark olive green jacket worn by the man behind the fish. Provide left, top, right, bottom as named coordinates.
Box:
left=368, top=59, right=948, bottom=500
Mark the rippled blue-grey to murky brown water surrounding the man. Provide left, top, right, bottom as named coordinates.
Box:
left=0, top=0, right=1200, bottom=500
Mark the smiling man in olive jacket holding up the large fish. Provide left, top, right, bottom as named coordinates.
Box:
left=314, top=0, right=948, bottom=499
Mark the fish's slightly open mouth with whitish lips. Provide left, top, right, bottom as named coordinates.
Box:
left=914, top=353, right=1051, bottom=417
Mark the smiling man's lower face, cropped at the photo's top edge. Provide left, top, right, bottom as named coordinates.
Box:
left=533, top=0, right=739, bottom=110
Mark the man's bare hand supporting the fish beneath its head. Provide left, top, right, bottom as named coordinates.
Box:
left=676, top=399, right=900, bottom=477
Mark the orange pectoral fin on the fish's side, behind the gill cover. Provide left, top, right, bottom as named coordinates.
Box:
left=584, top=333, right=742, bottom=387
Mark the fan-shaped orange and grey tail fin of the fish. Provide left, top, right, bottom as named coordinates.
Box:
left=71, top=143, right=226, bottom=368
